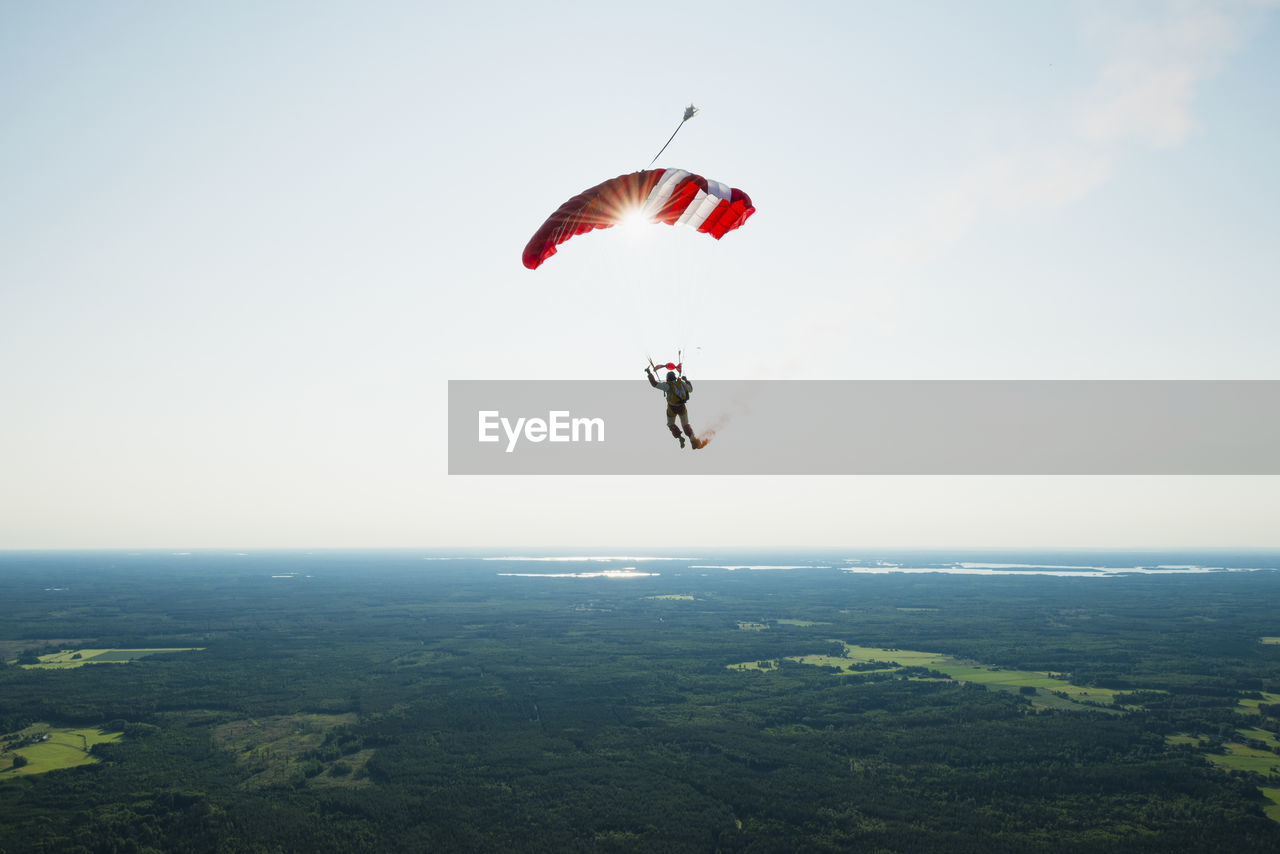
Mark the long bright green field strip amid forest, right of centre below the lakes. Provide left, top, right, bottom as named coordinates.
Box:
left=730, top=645, right=1119, bottom=708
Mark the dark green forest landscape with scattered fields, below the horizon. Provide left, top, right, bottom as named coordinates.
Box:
left=0, top=551, right=1280, bottom=854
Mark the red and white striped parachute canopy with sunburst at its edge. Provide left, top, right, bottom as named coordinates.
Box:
left=524, top=169, right=755, bottom=270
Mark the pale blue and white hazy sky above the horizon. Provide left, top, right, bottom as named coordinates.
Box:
left=0, top=0, right=1280, bottom=549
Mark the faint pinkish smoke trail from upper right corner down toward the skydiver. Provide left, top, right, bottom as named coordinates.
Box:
left=758, top=0, right=1280, bottom=375
